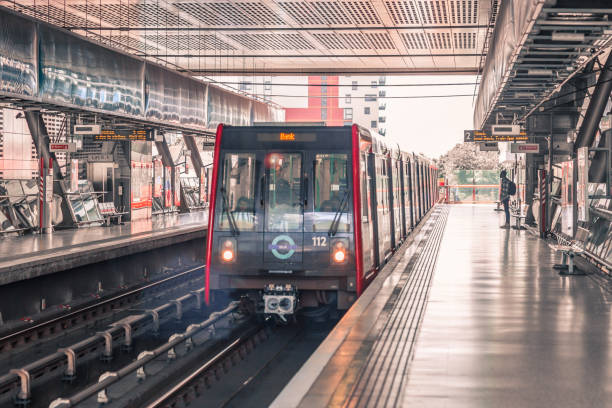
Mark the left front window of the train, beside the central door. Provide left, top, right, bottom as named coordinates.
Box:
left=216, top=153, right=255, bottom=231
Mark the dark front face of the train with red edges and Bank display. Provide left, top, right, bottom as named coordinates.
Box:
left=206, top=126, right=359, bottom=319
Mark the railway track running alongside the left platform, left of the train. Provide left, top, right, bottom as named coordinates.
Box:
left=0, top=266, right=204, bottom=355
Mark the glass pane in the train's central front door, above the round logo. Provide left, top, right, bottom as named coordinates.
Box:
left=266, top=153, right=303, bottom=232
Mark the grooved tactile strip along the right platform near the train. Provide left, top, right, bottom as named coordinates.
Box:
left=331, top=206, right=448, bottom=407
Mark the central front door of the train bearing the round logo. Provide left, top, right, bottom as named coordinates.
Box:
left=261, top=152, right=304, bottom=273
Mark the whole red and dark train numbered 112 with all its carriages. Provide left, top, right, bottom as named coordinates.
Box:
left=205, top=123, right=438, bottom=320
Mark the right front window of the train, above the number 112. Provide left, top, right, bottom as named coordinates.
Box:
left=309, top=154, right=351, bottom=232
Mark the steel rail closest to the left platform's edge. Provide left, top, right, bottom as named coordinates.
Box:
left=0, top=265, right=204, bottom=353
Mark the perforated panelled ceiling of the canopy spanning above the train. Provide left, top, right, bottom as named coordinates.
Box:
left=0, top=0, right=498, bottom=74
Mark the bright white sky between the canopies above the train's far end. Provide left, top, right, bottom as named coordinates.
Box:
left=386, top=75, right=476, bottom=158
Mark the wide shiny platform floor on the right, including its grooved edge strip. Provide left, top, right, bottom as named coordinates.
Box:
left=273, top=205, right=612, bottom=407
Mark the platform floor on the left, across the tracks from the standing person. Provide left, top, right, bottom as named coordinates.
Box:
left=0, top=211, right=208, bottom=285
